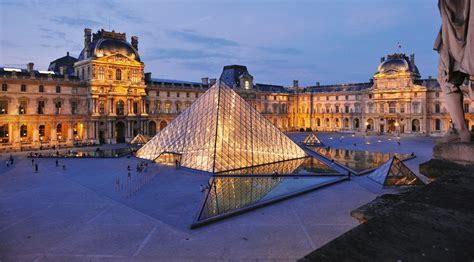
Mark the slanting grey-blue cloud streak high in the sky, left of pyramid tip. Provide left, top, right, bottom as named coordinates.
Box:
left=166, top=29, right=239, bottom=48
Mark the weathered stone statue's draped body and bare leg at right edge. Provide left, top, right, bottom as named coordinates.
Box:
left=434, top=0, right=474, bottom=143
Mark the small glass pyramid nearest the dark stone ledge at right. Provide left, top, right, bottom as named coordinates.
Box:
left=368, top=156, right=424, bottom=187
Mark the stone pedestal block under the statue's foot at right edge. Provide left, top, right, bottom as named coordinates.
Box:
left=433, top=142, right=474, bottom=165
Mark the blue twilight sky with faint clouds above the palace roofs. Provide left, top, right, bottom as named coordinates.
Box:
left=0, top=0, right=441, bottom=86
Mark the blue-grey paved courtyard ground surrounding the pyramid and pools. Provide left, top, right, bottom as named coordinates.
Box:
left=0, top=133, right=433, bottom=261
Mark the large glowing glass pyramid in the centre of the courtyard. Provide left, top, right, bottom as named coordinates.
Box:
left=137, top=81, right=306, bottom=173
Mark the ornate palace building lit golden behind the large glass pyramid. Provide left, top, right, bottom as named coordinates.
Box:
left=0, top=29, right=474, bottom=151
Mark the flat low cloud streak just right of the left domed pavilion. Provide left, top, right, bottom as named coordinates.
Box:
left=143, top=48, right=230, bottom=60
